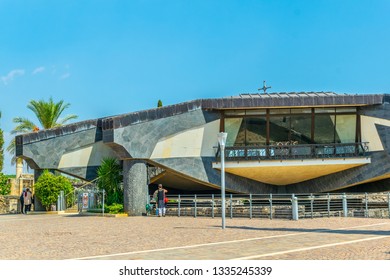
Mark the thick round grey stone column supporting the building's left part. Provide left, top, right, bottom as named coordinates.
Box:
left=123, top=160, right=148, bottom=216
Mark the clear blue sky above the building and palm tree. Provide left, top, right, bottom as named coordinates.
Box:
left=0, top=0, right=390, bottom=174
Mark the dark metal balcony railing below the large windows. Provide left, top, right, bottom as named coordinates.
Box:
left=215, top=141, right=368, bottom=161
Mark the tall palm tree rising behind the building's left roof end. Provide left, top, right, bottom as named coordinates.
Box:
left=7, top=97, right=77, bottom=164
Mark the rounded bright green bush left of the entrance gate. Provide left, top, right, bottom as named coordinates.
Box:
left=34, top=170, right=73, bottom=210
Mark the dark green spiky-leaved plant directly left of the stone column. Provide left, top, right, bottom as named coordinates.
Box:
left=97, top=158, right=123, bottom=205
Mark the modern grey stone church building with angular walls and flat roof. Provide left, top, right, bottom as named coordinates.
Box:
left=16, top=92, right=390, bottom=215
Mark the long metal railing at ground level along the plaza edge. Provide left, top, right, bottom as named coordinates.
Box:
left=153, top=193, right=390, bottom=220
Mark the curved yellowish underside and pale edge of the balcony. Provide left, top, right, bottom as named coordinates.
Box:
left=213, top=157, right=371, bottom=186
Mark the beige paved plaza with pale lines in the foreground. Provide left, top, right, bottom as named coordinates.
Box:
left=0, top=214, right=390, bottom=260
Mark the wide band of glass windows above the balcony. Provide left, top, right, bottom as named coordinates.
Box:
left=225, top=107, right=357, bottom=146
